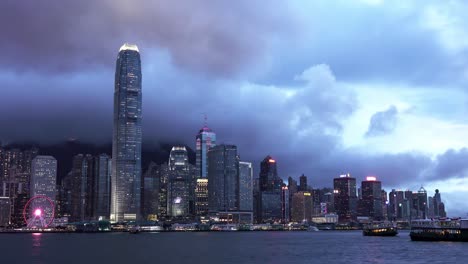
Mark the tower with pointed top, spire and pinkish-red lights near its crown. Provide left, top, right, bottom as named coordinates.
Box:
left=195, top=123, right=216, bottom=178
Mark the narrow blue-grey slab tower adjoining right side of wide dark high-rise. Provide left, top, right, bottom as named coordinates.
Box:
left=239, top=161, right=253, bottom=212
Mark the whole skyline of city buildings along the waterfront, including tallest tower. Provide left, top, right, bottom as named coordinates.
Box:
left=0, top=44, right=445, bottom=226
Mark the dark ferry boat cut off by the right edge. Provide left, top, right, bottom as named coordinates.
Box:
left=410, top=218, right=468, bottom=242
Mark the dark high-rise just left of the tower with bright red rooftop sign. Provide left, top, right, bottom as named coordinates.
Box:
left=333, top=174, right=357, bottom=223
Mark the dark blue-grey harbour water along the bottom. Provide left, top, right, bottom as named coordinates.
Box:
left=0, top=231, right=468, bottom=264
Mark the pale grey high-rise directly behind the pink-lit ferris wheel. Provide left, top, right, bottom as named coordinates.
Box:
left=30, top=156, right=57, bottom=201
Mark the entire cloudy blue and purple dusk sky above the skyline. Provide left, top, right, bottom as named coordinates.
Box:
left=0, top=0, right=468, bottom=216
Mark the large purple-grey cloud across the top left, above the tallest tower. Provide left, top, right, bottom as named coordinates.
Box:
left=0, top=0, right=288, bottom=77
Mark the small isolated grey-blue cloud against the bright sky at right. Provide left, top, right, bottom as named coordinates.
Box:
left=365, top=105, right=398, bottom=137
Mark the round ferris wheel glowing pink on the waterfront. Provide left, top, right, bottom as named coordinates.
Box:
left=23, top=195, right=55, bottom=228
